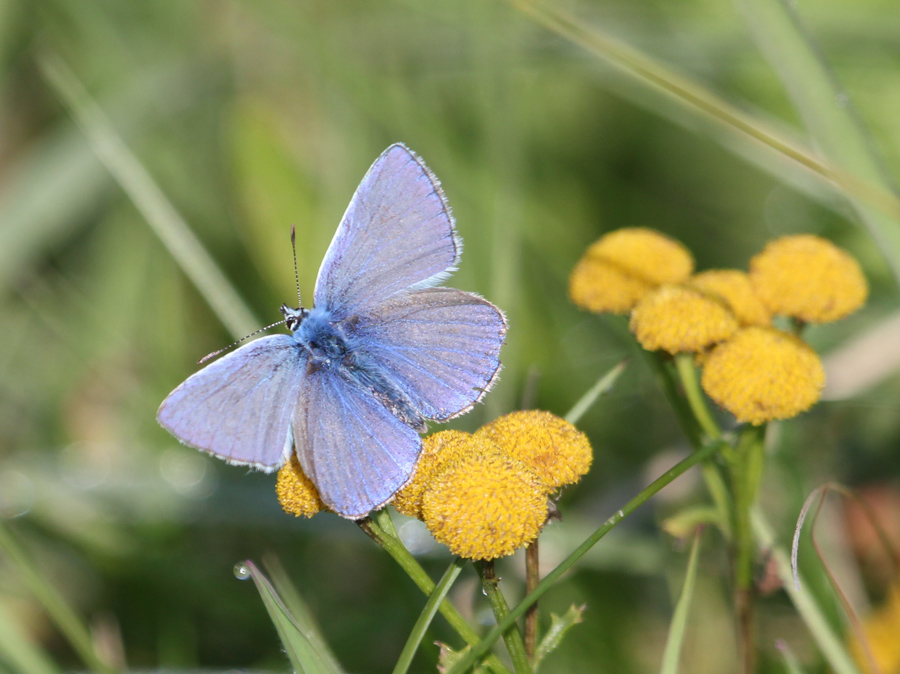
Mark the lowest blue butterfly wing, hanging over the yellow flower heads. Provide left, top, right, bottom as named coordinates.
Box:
left=293, top=369, right=421, bottom=519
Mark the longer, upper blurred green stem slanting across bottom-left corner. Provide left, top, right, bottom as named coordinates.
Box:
left=0, top=524, right=117, bottom=674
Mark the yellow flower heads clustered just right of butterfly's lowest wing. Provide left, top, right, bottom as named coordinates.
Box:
left=393, top=410, right=592, bottom=559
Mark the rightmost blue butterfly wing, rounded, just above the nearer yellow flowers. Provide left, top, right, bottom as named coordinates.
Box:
left=358, top=288, right=506, bottom=421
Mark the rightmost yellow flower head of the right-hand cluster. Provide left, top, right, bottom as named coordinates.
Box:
left=750, top=234, right=869, bottom=323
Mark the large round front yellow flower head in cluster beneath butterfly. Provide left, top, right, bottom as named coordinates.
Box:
left=422, top=448, right=547, bottom=559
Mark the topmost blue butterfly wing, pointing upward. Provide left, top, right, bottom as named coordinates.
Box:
left=315, top=144, right=460, bottom=319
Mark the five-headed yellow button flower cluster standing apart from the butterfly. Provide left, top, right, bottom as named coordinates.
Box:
left=569, top=229, right=868, bottom=424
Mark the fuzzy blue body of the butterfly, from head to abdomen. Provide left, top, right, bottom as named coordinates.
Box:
left=282, top=307, right=425, bottom=432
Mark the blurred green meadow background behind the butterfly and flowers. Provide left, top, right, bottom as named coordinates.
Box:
left=0, top=0, right=900, bottom=673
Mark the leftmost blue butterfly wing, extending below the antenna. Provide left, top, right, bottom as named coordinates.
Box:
left=156, top=335, right=306, bottom=471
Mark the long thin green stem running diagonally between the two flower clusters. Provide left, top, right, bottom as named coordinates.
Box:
left=445, top=440, right=725, bottom=674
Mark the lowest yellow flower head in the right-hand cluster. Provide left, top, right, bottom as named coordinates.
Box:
left=701, top=327, right=825, bottom=425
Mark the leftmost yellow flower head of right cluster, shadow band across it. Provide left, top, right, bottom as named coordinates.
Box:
left=569, top=227, right=694, bottom=314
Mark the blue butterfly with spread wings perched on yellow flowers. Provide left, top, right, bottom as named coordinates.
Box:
left=157, top=144, right=506, bottom=519
